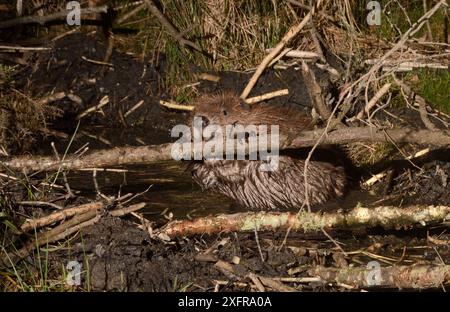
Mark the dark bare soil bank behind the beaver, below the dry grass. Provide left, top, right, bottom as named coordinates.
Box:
left=10, top=33, right=335, bottom=153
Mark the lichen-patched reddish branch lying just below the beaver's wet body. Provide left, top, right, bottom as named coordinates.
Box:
left=158, top=206, right=450, bottom=238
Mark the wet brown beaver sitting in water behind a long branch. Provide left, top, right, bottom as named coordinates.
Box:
left=191, top=93, right=346, bottom=210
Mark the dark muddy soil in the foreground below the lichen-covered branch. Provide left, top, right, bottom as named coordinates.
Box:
left=53, top=213, right=450, bottom=291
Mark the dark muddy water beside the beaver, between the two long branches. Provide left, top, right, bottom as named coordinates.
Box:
left=68, top=161, right=234, bottom=218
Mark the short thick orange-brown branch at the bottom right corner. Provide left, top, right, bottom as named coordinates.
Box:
left=308, top=264, right=450, bottom=289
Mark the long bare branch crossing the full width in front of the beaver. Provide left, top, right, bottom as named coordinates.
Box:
left=0, top=127, right=450, bottom=173
